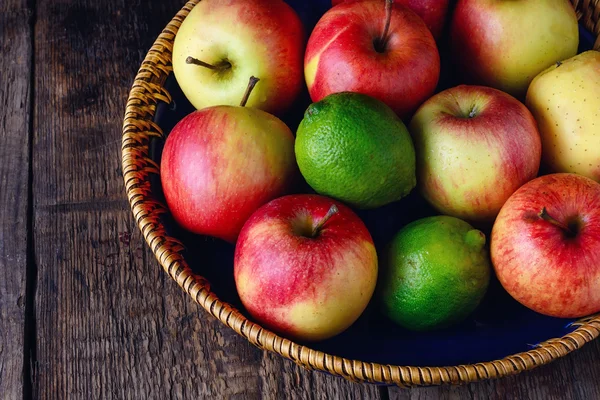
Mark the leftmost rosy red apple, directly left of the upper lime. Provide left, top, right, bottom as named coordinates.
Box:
left=160, top=106, right=298, bottom=242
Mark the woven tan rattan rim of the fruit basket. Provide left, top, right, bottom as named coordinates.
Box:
left=122, top=0, right=600, bottom=387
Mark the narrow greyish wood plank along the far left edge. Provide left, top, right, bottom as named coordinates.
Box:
left=0, top=0, right=32, bottom=399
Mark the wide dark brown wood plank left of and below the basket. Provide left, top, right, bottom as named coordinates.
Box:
left=33, top=0, right=379, bottom=399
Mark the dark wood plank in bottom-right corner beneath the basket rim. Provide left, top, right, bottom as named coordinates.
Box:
left=389, top=340, right=600, bottom=400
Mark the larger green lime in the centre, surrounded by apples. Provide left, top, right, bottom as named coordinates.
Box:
left=295, top=92, right=416, bottom=208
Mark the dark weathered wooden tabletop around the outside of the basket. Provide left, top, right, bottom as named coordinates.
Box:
left=0, top=0, right=600, bottom=399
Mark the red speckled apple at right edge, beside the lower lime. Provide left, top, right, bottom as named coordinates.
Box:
left=491, top=174, right=600, bottom=318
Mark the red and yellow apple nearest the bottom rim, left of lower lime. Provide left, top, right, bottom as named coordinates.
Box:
left=234, top=195, right=377, bottom=341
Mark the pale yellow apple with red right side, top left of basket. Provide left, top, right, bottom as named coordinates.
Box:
left=173, top=0, right=305, bottom=114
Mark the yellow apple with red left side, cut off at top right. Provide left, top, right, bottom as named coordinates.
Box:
left=451, top=0, right=579, bottom=98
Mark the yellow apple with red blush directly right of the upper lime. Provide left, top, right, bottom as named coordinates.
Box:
left=410, top=85, right=541, bottom=222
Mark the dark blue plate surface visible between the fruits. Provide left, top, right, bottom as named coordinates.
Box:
left=151, top=0, right=593, bottom=366
